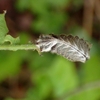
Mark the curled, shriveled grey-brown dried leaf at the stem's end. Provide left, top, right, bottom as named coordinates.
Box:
left=36, top=34, right=90, bottom=63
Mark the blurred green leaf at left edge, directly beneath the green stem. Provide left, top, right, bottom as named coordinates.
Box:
left=0, top=51, right=24, bottom=82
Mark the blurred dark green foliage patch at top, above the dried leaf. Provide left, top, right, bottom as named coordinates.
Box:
left=16, top=0, right=70, bottom=34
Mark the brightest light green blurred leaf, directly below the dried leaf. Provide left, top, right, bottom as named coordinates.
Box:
left=49, top=57, right=78, bottom=97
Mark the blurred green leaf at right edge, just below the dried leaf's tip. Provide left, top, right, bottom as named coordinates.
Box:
left=82, top=54, right=100, bottom=83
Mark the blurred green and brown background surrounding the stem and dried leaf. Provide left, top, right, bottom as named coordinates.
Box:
left=0, top=0, right=100, bottom=100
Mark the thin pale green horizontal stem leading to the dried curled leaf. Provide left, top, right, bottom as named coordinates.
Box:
left=0, top=44, right=37, bottom=51
